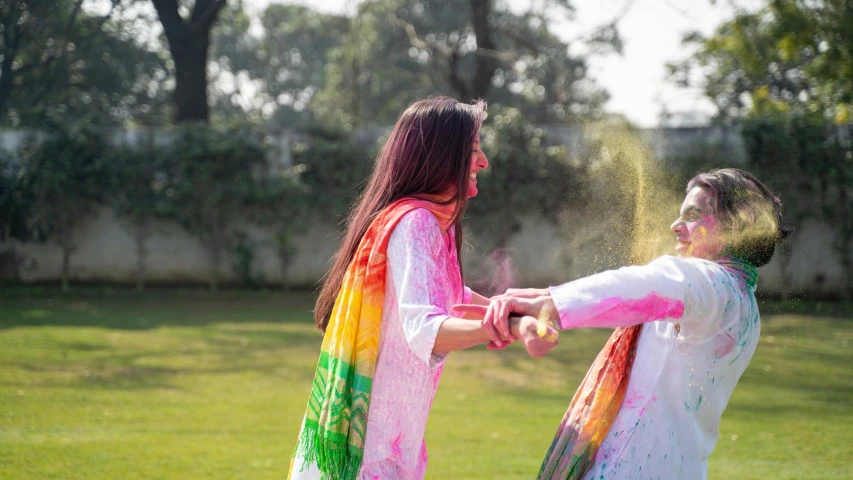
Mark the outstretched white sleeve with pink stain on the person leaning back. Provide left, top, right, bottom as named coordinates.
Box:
left=550, top=256, right=731, bottom=336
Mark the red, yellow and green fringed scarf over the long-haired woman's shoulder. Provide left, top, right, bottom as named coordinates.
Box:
left=292, top=195, right=455, bottom=480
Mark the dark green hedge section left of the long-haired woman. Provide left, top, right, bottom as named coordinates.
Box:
left=0, top=124, right=371, bottom=289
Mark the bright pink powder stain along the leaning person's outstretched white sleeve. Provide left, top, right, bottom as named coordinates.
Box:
left=560, top=292, right=684, bottom=329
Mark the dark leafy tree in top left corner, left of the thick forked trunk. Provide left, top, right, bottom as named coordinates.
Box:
left=0, top=0, right=167, bottom=126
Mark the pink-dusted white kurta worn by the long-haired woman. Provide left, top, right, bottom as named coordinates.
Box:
left=289, top=209, right=471, bottom=480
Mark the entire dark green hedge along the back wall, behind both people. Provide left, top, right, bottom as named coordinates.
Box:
left=0, top=116, right=853, bottom=293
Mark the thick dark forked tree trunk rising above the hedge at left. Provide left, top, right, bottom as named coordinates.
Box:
left=151, top=0, right=226, bottom=123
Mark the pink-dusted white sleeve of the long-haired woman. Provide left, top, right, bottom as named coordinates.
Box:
left=387, top=209, right=449, bottom=366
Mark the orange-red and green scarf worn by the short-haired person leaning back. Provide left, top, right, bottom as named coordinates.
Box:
left=538, top=256, right=758, bottom=480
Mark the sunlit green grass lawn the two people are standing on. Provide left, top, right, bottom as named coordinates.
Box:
left=0, top=289, right=853, bottom=480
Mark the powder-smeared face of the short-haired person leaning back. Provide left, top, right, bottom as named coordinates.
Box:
left=670, top=187, right=725, bottom=260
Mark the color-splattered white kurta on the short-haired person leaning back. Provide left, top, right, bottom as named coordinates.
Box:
left=551, top=256, right=760, bottom=480
